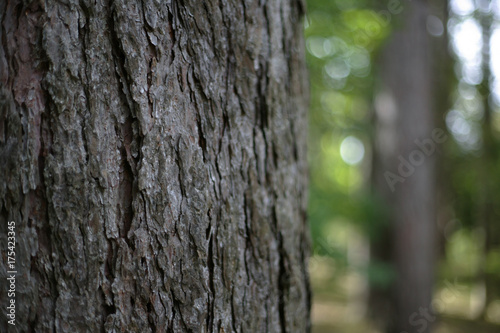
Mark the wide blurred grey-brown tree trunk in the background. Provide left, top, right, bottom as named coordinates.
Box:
left=372, top=0, right=438, bottom=333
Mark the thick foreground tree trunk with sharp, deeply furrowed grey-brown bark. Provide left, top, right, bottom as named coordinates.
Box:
left=0, top=0, right=310, bottom=332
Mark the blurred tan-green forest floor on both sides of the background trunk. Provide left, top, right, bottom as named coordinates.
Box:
left=311, top=258, right=500, bottom=333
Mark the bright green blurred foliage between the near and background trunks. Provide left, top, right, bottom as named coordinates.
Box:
left=305, top=0, right=389, bottom=256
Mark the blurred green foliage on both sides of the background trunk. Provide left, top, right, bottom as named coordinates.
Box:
left=305, top=0, right=500, bottom=326
